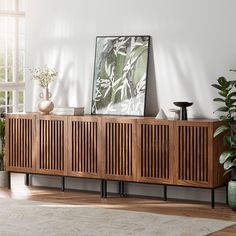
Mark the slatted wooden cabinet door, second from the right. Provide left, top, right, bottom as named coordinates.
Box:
left=137, top=118, right=174, bottom=184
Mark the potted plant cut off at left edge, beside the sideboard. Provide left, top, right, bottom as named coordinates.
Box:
left=0, top=115, right=9, bottom=187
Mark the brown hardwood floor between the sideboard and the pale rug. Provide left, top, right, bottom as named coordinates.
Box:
left=0, top=174, right=236, bottom=236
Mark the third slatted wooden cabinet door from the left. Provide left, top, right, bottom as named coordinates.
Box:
left=68, top=116, right=102, bottom=178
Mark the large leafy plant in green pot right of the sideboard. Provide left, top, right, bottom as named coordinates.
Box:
left=212, top=70, right=236, bottom=210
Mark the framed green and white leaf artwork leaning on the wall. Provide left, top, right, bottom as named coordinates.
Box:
left=92, top=36, right=150, bottom=116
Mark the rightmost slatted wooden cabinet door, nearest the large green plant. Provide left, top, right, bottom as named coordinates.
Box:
left=174, top=120, right=219, bottom=187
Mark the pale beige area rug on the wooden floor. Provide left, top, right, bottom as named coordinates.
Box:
left=0, top=199, right=235, bottom=236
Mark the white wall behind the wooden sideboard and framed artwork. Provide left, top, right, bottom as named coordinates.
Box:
left=26, top=0, right=236, bottom=202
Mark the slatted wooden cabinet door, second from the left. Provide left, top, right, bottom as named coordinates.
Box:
left=36, top=115, right=67, bottom=175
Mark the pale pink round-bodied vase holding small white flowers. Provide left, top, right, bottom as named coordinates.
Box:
left=38, top=87, right=54, bottom=115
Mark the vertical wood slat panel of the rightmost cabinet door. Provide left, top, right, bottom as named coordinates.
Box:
left=175, top=122, right=210, bottom=186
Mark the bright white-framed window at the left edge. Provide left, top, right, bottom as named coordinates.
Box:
left=0, top=0, right=25, bottom=113
